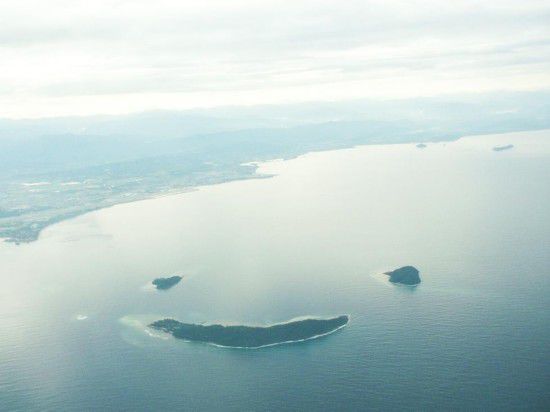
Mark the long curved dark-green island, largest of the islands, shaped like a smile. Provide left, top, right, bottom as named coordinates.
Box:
left=149, top=315, right=349, bottom=349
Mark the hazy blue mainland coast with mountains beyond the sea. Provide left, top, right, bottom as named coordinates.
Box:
left=0, top=92, right=550, bottom=244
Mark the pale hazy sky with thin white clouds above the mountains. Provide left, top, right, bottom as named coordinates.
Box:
left=0, top=0, right=550, bottom=117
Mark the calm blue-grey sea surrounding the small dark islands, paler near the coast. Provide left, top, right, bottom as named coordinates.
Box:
left=0, top=131, right=550, bottom=411
